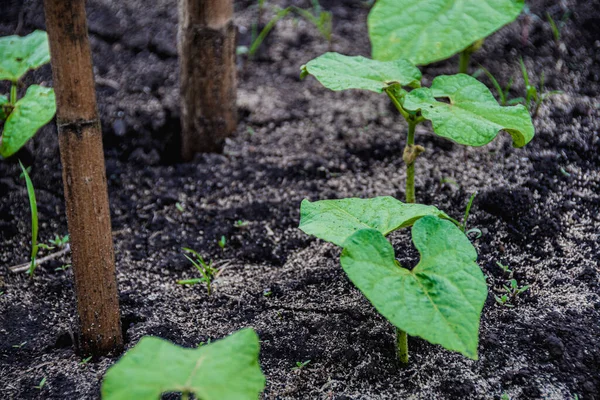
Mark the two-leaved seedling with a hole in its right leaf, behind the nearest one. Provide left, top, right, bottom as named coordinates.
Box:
left=301, top=53, right=534, bottom=203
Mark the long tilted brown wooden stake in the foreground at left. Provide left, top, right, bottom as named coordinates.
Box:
left=44, top=0, right=123, bottom=355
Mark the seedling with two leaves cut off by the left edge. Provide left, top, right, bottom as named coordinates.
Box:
left=0, top=31, right=56, bottom=158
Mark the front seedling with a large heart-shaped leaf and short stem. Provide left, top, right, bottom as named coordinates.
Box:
left=300, top=197, right=487, bottom=363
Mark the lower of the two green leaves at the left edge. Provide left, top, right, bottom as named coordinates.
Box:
left=0, top=85, right=56, bottom=158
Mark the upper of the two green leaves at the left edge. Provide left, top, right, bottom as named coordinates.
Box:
left=0, top=30, right=50, bottom=82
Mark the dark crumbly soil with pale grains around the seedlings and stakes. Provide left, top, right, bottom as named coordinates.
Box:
left=0, top=0, right=600, bottom=400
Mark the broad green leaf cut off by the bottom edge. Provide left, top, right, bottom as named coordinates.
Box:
left=102, top=329, right=265, bottom=400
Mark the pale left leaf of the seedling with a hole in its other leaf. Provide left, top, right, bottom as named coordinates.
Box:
left=300, top=53, right=421, bottom=93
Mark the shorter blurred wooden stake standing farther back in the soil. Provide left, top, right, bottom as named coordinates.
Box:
left=178, top=0, right=237, bottom=161
